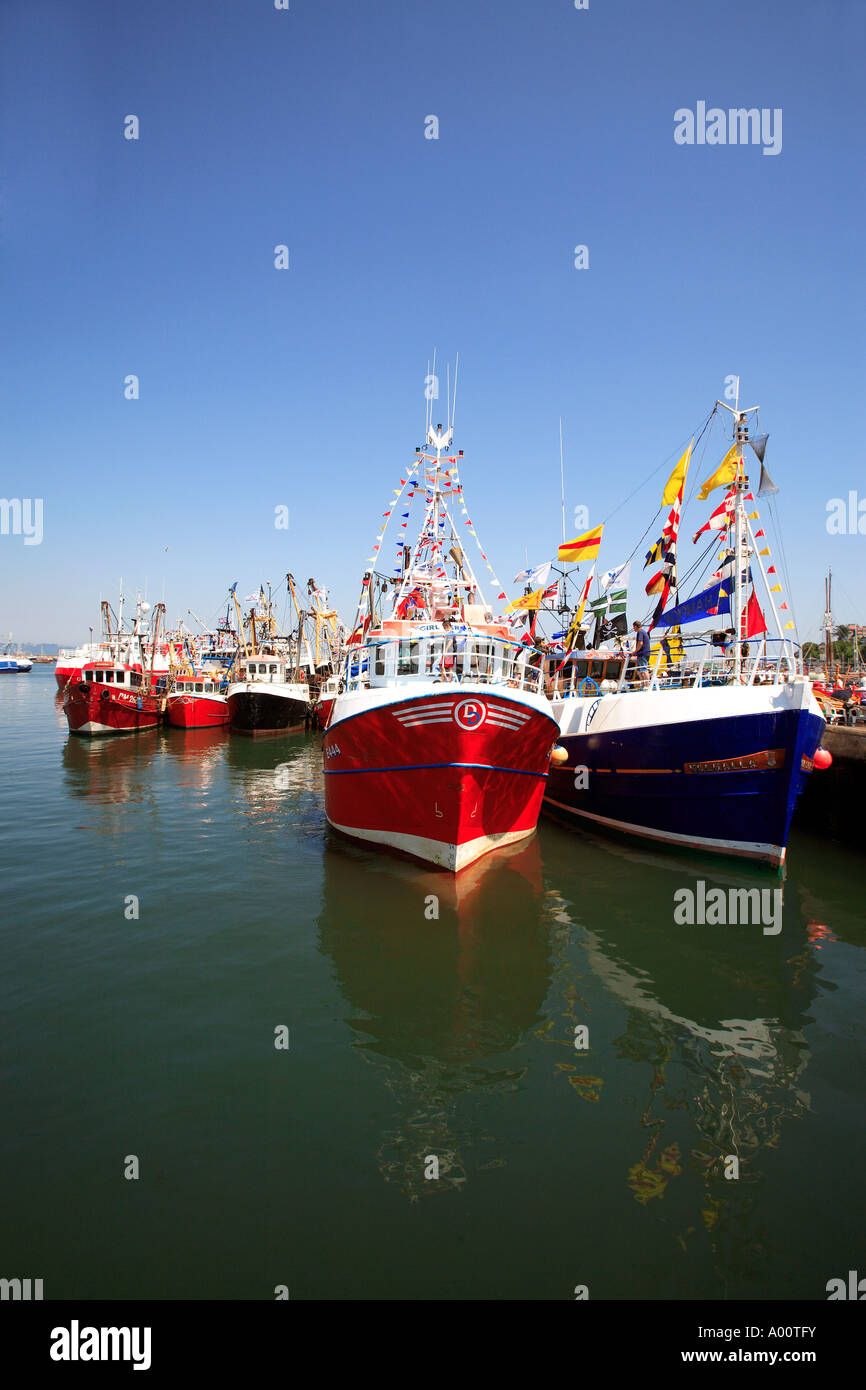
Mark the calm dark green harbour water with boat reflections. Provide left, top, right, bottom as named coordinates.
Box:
left=0, top=667, right=866, bottom=1300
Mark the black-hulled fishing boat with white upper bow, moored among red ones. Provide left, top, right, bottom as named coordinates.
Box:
left=227, top=574, right=310, bottom=735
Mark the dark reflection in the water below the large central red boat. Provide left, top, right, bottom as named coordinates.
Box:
left=318, top=835, right=550, bottom=1201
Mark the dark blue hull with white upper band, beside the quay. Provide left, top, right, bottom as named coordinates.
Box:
left=544, top=684, right=824, bottom=866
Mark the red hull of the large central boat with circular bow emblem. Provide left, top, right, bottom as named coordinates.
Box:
left=322, top=685, right=557, bottom=873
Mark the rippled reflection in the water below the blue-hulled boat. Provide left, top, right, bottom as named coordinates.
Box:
left=545, top=834, right=822, bottom=1280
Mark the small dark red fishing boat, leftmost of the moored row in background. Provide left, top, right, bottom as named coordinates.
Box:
left=63, top=600, right=168, bottom=737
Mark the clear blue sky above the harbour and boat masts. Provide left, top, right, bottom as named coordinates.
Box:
left=0, top=0, right=866, bottom=642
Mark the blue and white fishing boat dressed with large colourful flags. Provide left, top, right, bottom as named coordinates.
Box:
left=545, top=389, right=824, bottom=866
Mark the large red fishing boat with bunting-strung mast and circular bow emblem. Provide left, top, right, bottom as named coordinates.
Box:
left=322, top=392, right=557, bottom=873
